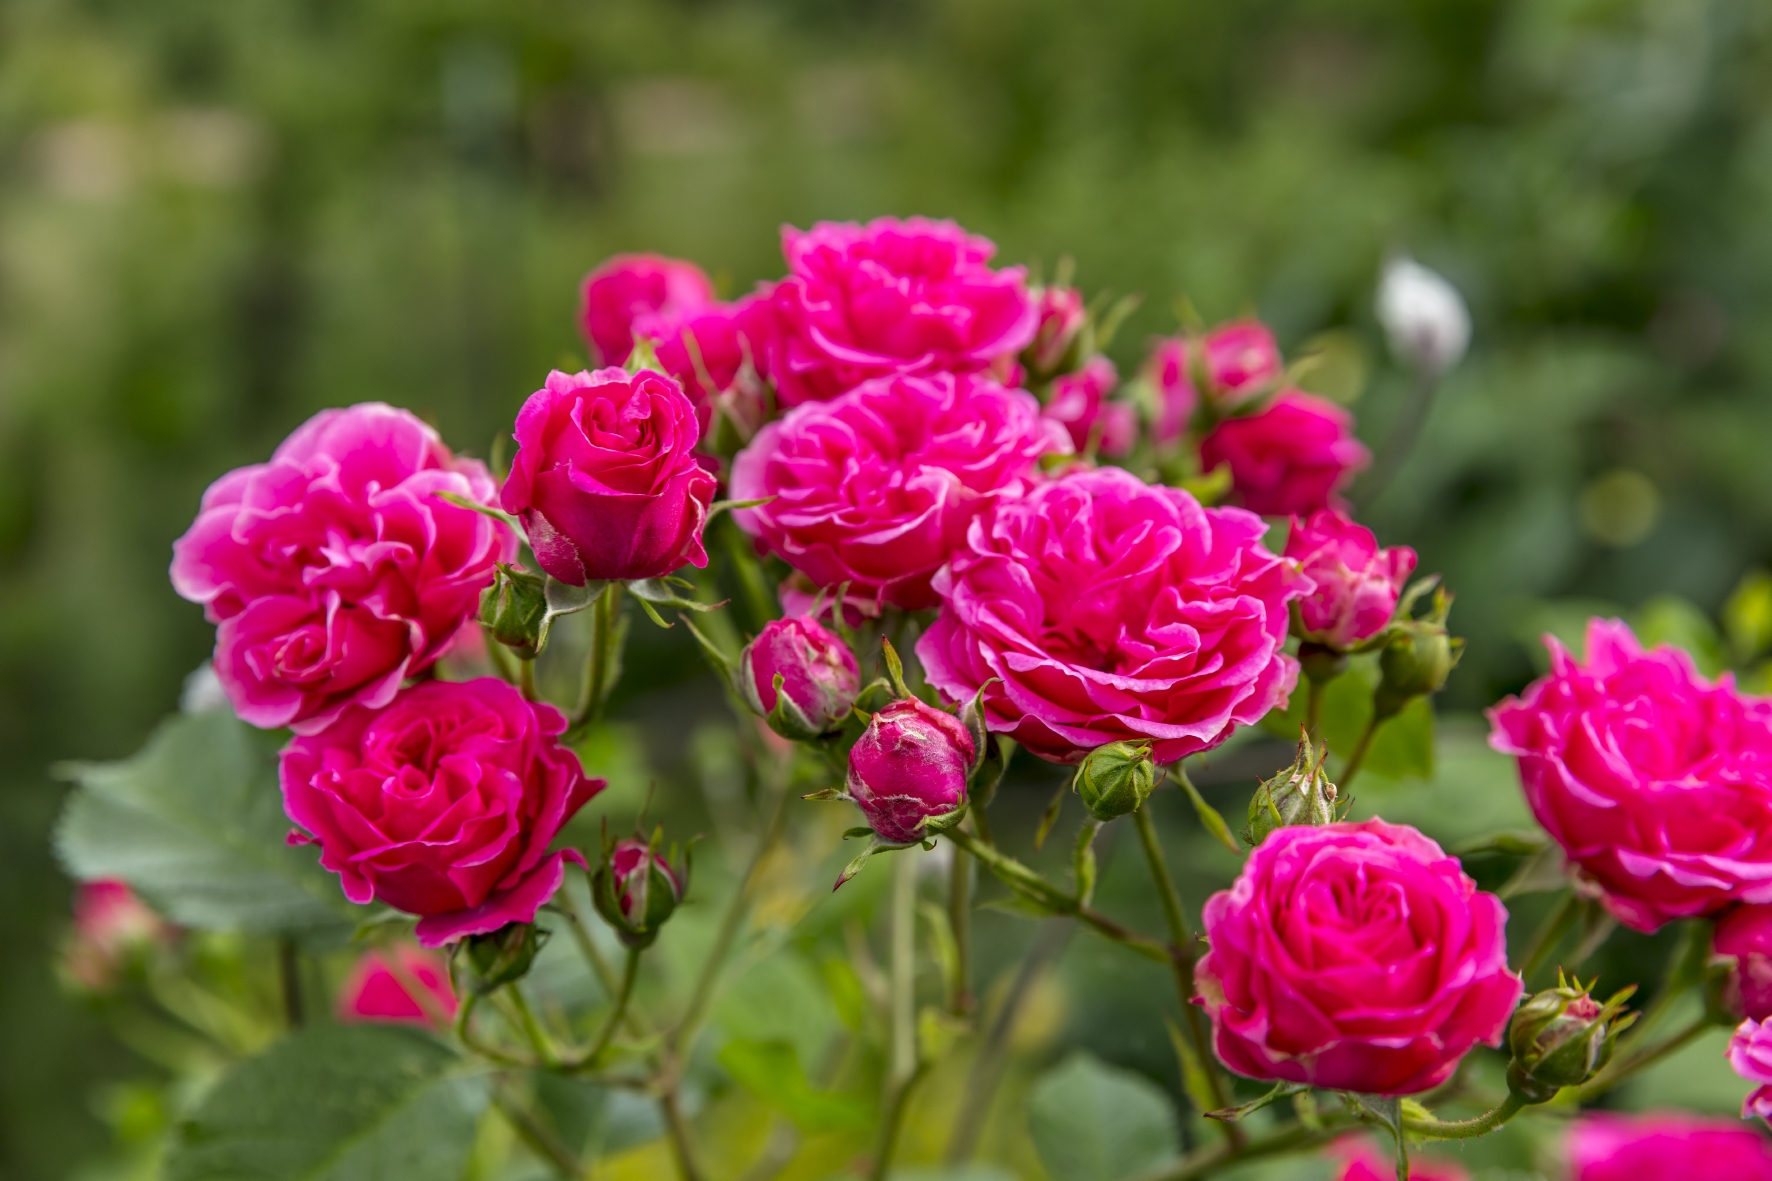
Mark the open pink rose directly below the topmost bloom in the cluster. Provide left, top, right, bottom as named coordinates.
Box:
left=732, top=374, right=1070, bottom=610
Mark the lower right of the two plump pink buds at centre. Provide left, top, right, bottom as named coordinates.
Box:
left=849, top=697, right=976, bottom=844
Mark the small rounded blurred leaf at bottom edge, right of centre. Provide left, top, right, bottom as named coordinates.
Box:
left=1028, top=1050, right=1180, bottom=1181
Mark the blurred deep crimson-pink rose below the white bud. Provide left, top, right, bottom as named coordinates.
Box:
left=1200, top=390, right=1372, bottom=516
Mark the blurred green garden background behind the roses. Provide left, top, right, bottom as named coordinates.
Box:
left=0, top=0, right=1772, bottom=1179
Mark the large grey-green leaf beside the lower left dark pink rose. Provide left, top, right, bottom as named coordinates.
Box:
left=55, top=709, right=354, bottom=942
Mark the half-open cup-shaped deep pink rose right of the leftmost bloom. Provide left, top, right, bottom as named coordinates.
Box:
left=503, top=369, right=719, bottom=587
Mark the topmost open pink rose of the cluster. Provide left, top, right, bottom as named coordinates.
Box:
left=769, top=218, right=1040, bottom=406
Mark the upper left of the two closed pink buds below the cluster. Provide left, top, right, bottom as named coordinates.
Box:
left=739, top=615, right=861, bottom=741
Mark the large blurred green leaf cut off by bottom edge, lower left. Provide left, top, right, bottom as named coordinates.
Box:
left=163, top=1025, right=489, bottom=1181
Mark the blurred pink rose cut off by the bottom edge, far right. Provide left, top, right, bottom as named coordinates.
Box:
left=1568, top=1112, right=1772, bottom=1181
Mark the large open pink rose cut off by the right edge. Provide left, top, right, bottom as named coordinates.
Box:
left=1488, top=619, right=1772, bottom=931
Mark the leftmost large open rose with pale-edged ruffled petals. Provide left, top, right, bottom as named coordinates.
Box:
left=172, top=403, right=517, bottom=734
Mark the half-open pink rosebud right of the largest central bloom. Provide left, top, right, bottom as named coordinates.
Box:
left=1286, top=509, right=1416, bottom=651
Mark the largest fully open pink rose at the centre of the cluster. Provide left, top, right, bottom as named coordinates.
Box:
left=916, top=468, right=1306, bottom=763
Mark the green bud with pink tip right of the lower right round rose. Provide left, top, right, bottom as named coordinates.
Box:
left=1508, top=974, right=1637, bottom=1103
